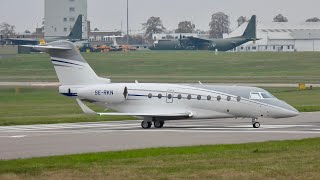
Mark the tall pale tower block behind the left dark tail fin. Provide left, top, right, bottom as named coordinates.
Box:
left=44, top=0, right=88, bottom=39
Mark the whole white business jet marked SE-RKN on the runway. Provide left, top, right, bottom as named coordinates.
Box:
left=23, top=41, right=299, bottom=129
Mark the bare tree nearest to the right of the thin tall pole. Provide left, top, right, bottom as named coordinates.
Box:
left=142, top=16, right=166, bottom=39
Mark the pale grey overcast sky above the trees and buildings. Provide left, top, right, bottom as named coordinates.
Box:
left=0, top=0, right=320, bottom=32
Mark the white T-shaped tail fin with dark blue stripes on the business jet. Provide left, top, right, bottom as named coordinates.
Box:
left=25, top=41, right=110, bottom=86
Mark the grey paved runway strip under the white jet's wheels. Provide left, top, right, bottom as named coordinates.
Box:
left=0, top=112, right=320, bottom=159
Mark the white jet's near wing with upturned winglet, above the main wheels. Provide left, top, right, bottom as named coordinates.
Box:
left=76, top=98, right=193, bottom=118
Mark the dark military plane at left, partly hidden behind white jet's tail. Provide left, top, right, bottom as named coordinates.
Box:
left=4, top=15, right=84, bottom=45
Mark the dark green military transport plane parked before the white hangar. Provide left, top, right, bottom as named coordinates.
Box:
left=150, top=15, right=259, bottom=51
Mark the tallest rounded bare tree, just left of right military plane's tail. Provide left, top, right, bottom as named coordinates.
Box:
left=209, top=12, right=230, bottom=38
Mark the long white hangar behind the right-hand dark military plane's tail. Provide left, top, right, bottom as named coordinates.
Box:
left=224, top=22, right=320, bottom=52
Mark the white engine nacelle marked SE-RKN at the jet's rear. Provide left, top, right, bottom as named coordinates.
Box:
left=78, top=84, right=128, bottom=104
